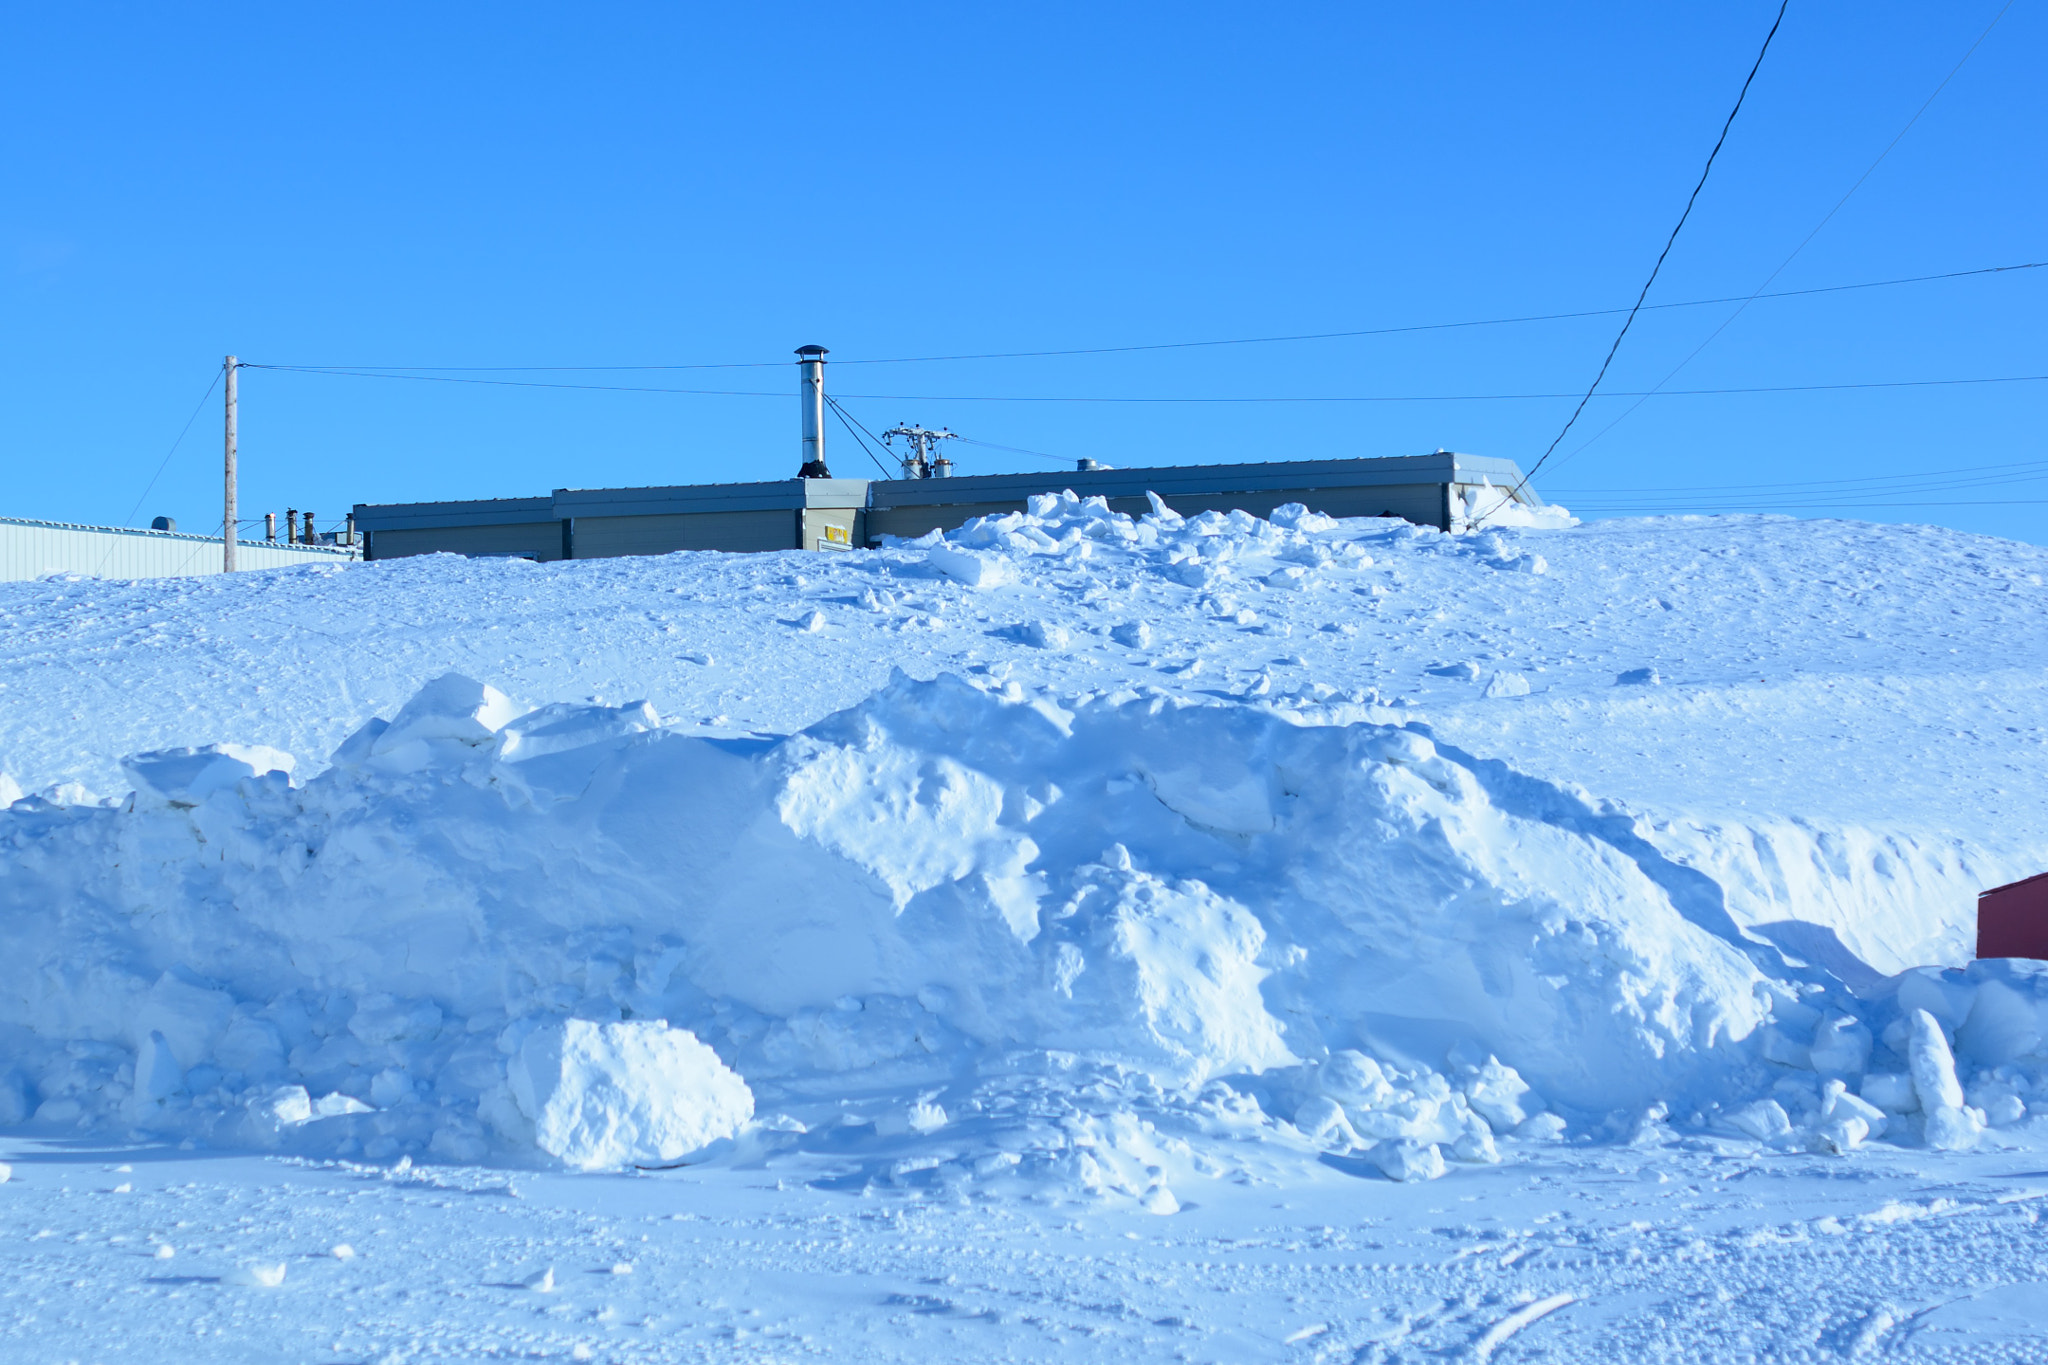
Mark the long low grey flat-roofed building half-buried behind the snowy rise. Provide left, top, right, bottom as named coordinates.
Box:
left=354, top=450, right=1542, bottom=561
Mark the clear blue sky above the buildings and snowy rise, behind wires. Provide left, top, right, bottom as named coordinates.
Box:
left=0, top=0, right=2048, bottom=542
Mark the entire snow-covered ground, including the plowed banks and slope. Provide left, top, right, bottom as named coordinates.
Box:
left=0, top=499, right=2048, bottom=1361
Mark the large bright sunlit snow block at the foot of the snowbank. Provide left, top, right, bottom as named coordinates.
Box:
left=510, top=1019, right=754, bottom=1171
